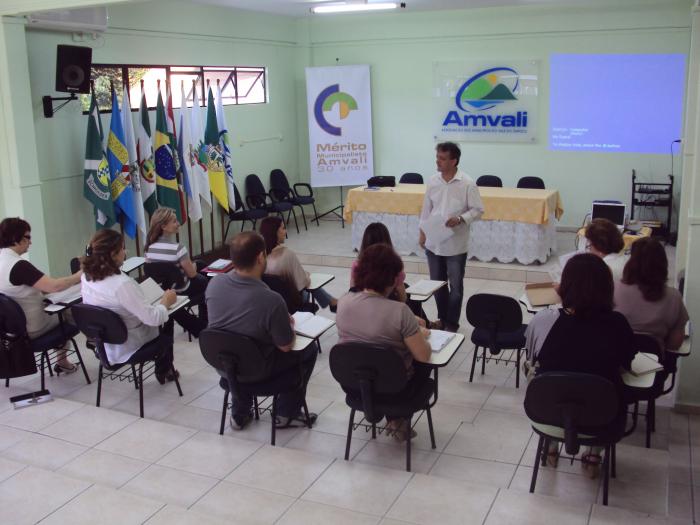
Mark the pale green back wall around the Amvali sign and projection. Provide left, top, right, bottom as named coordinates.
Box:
left=300, top=0, right=692, bottom=226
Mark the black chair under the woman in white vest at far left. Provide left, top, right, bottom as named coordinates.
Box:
left=0, top=294, right=90, bottom=390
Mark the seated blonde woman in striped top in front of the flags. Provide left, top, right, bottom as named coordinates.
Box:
left=144, top=207, right=207, bottom=337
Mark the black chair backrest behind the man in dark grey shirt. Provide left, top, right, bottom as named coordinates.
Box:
left=199, top=328, right=271, bottom=382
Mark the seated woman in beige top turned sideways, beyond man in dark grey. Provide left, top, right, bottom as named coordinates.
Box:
left=260, top=217, right=338, bottom=312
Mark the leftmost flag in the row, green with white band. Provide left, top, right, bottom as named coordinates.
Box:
left=83, top=93, right=116, bottom=229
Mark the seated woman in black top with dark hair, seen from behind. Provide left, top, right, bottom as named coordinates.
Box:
left=525, top=254, right=635, bottom=477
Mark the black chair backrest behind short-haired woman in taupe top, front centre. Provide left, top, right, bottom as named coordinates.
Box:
left=328, top=343, right=408, bottom=423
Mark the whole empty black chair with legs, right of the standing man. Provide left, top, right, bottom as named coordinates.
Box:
left=467, top=293, right=527, bottom=388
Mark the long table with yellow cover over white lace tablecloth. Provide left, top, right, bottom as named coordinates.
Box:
left=345, top=184, right=563, bottom=264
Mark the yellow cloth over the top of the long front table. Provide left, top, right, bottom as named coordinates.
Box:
left=344, top=184, right=564, bottom=224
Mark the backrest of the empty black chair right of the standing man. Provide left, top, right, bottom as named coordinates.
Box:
left=467, top=293, right=523, bottom=352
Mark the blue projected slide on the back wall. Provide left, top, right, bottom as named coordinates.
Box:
left=549, top=54, right=686, bottom=153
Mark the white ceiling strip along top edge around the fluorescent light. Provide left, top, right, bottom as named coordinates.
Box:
left=194, top=0, right=590, bottom=17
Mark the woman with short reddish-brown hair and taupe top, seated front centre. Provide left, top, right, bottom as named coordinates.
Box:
left=336, top=244, right=431, bottom=440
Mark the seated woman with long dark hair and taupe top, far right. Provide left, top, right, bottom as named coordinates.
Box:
left=615, top=237, right=688, bottom=350
